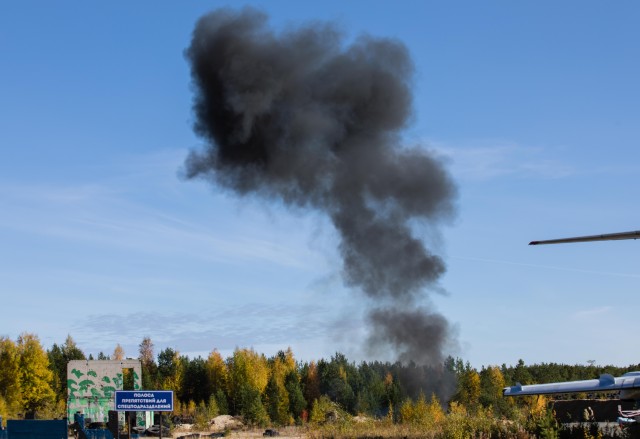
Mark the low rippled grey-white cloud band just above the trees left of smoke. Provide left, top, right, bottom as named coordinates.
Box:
left=71, top=303, right=333, bottom=356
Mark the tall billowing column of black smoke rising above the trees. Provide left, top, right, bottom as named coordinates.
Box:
left=186, top=9, right=456, bottom=365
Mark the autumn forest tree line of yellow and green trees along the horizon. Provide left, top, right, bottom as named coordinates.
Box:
left=0, top=333, right=640, bottom=425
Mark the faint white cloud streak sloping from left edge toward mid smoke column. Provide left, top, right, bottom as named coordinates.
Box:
left=0, top=153, right=317, bottom=268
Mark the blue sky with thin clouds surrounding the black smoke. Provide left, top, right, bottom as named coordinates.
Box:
left=0, top=0, right=640, bottom=367
